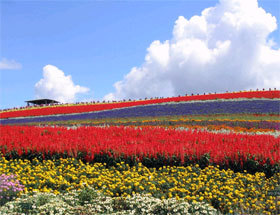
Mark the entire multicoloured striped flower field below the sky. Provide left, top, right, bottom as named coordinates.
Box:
left=0, top=90, right=280, bottom=214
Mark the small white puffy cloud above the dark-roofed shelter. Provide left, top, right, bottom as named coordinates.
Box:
left=35, top=65, right=89, bottom=103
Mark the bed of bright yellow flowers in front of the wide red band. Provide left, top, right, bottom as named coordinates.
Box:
left=0, top=157, right=280, bottom=214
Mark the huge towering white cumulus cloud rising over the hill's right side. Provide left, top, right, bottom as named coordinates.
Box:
left=104, top=0, right=280, bottom=100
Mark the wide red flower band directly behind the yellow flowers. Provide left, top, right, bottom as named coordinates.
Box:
left=0, top=126, right=280, bottom=171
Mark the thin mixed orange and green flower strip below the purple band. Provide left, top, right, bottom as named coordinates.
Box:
left=21, top=114, right=280, bottom=136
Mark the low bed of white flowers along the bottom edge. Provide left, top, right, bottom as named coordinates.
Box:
left=0, top=187, right=218, bottom=215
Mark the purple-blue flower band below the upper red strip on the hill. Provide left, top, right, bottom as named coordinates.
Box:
left=0, top=100, right=280, bottom=125
